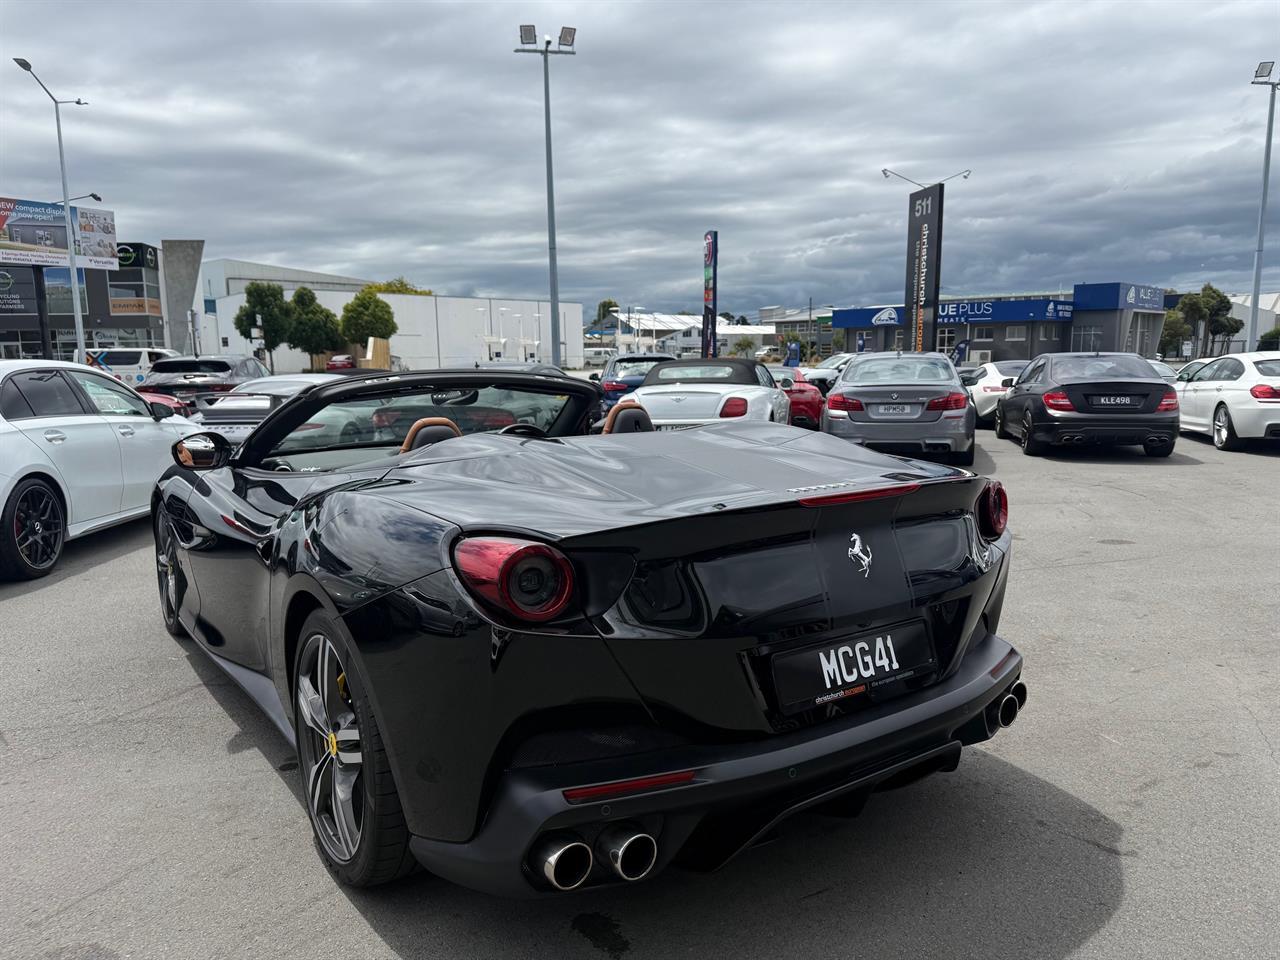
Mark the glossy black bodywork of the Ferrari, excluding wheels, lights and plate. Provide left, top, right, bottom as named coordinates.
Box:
left=156, top=371, right=1021, bottom=895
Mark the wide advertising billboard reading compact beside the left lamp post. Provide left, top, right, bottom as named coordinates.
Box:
left=0, top=197, right=119, bottom=270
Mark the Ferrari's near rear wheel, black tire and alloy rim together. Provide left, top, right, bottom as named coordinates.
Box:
left=293, top=611, right=417, bottom=887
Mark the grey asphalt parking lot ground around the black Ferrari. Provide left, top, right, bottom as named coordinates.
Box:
left=0, top=431, right=1280, bottom=960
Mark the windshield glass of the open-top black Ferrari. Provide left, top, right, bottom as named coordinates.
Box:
left=270, top=387, right=570, bottom=456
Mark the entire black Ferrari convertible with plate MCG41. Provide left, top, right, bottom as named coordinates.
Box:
left=152, top=370, right=1027, bottom=896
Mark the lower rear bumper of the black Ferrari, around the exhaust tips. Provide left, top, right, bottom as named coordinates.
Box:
left=411, top=634, right=1023, bottom=897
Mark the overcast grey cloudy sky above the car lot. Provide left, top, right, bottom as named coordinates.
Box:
left=0, top=0, right=1280, bottom=314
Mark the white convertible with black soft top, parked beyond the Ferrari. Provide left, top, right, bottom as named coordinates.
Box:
left=627, top=358, right=791, bottom=430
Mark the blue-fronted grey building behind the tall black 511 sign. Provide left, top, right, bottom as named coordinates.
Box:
left=832, top=282, right=1165, bottom=364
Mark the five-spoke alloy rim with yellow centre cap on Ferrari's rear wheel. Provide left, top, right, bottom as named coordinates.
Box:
left=297, top=634, right=365, bottom=863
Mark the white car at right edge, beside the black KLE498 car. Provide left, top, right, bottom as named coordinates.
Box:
left=1175, top=351, right=1280, bottom=451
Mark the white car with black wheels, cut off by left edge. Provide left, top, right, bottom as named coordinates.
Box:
left=0, top=360, right=200, bottom=580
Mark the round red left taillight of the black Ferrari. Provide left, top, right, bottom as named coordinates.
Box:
left=453, top=536, right=573, bottom=623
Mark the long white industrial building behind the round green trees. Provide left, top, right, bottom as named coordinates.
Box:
left=193, top=260, right=582, bottom=372
